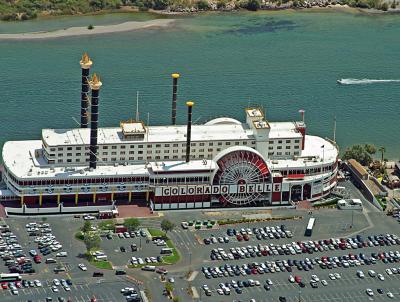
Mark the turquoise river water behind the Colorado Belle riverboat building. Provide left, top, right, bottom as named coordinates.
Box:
left=0, top=11, right=400, bottom=158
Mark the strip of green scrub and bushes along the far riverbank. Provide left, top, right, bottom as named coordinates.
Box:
left=0, top=0, right=400, bottom=21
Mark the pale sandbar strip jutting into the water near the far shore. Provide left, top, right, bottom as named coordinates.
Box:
left=0, top=19, right=175, bottom=40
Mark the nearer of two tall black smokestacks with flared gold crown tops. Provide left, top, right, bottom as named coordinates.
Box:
left=89, top=74, right=102, bottom=169
